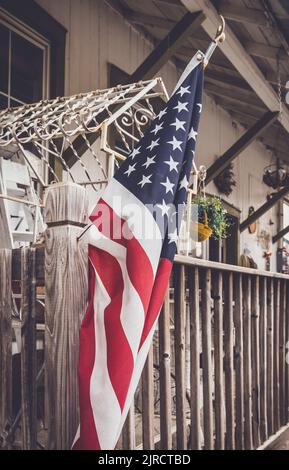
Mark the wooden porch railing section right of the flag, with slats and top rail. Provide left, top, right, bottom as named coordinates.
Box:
left=120, top=256, right=289, bottom=449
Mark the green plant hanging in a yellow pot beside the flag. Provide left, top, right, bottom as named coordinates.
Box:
left=190, top=194, right=230, bottom=242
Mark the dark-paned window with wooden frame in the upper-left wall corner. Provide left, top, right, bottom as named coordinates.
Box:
left=0, top=10, right=50, bottom=109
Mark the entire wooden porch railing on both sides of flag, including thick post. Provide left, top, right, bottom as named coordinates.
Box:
left=0, top=186, right=289, bottom=450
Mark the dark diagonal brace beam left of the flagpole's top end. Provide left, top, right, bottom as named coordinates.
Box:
left=129, top=11, right=206, bottom=83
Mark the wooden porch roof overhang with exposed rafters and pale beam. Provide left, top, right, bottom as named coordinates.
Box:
left=106, top=0, right=289, bottom=162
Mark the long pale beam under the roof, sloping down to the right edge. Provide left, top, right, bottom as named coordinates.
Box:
left=181, top=0, right=289, bottom=133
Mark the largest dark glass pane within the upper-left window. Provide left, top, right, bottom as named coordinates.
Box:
left=11, top=33, right=43, bottom=103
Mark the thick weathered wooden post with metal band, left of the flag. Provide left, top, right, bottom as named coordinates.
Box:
left=45, top=183, right=88, bottom=449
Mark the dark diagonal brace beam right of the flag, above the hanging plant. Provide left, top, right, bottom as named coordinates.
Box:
left=206, top=111, right=279, bottom=184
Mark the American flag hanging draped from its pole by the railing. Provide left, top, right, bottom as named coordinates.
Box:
left=73, top=53, right=203, bottom=450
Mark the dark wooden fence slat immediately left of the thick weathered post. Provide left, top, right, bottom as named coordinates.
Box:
left=21, top=248, right=37, bottom=450
